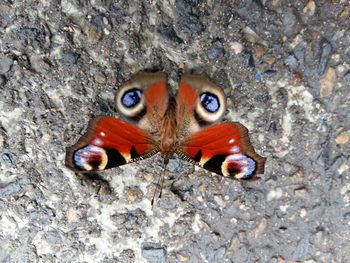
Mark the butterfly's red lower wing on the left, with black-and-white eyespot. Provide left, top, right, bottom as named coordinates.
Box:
left=66, top=117, right=157, bottom=172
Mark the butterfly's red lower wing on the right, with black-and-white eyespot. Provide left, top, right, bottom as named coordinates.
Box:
left=179, top=122, right=265, bottom=179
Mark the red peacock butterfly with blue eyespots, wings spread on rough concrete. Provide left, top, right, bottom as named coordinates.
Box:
left=65, top=72, right=265, bottom=180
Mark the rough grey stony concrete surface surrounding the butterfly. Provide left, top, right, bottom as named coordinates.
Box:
left=0, top=0, right=350, bottom=263
